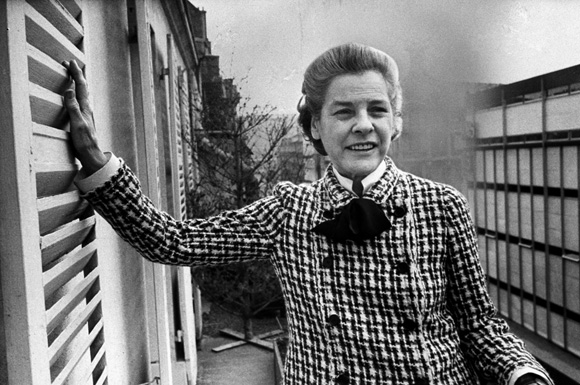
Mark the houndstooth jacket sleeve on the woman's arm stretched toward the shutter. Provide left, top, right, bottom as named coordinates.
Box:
left=83, top=159, right=284, bottom=266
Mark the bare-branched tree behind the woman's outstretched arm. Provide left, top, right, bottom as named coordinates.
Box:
left=188, top=80, right=304, bottom=340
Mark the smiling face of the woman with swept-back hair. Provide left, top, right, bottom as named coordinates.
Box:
left=312, top=71, right=394, bottom=180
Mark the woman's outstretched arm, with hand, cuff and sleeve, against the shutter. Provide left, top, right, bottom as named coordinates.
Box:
left=62, top=61, right=283, bottom=265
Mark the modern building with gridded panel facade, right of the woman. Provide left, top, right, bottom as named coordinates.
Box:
left=469, top=66, right=580, bottom=384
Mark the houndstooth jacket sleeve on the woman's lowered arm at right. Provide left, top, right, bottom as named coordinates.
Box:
left=445, top=190, right=549, bottom=385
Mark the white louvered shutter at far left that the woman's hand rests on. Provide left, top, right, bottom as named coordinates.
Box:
left=0, top=0, right=107, bottom=385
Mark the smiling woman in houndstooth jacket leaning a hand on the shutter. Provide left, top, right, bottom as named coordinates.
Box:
left=64, top=44, right=552, bottom=385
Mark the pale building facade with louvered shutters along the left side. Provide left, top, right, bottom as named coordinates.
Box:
left=0, top=0, right=210, bottom=385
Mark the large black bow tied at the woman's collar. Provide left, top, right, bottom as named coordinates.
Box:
left=312, top=198, right=391, bottom=242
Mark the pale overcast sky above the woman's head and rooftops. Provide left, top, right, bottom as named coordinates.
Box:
left=190, top=0, right=580, bottom=113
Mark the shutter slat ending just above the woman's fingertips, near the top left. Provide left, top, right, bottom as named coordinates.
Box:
left=25, top=5, right=85, bottom=68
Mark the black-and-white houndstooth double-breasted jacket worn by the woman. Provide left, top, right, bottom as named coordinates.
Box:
left=85, top=158, right=545, bottom=385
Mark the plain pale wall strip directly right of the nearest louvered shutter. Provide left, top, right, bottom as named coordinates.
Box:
left=84, top=1, right=151, bottom=384
